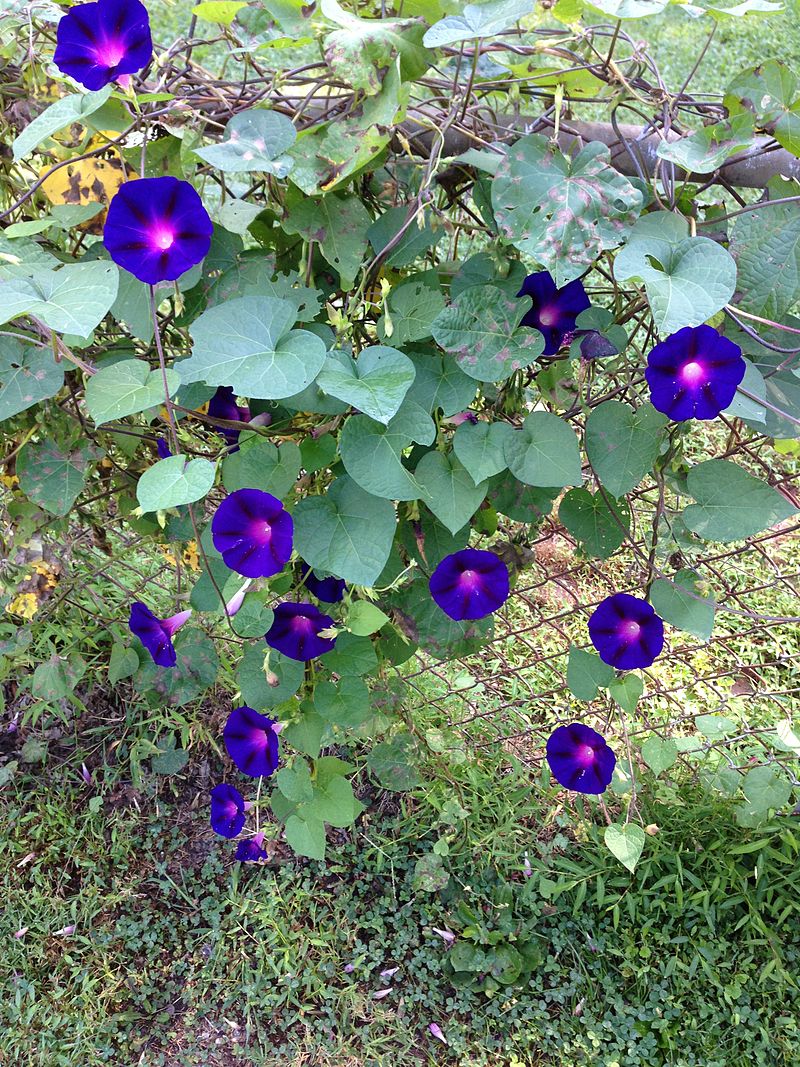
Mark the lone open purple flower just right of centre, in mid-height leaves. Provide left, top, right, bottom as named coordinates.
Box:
left=430, top=548, right=509, bottom=619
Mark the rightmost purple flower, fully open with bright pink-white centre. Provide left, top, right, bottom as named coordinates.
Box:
left=644, top=325, right=747, bottom=423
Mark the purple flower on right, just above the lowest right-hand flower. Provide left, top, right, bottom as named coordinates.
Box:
left=589, top=593, right=663, bottom=670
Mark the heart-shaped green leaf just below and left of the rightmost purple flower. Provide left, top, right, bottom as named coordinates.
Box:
left=586, top=400, right=669, bottom=497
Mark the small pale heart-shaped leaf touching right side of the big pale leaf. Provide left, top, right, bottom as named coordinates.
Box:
left=317, top=345, right=415, bottom=425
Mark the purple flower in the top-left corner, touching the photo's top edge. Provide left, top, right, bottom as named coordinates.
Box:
left=53, top=0, right=153, bottom=90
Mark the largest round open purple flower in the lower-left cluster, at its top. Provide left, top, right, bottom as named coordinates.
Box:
left=211, top=489, right=293, bottom=578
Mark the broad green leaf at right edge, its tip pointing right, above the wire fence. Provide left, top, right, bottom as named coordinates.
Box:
left=683, top=460, right=797, bottom=541
